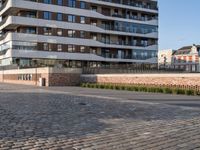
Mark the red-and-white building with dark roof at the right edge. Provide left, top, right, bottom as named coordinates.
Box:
left=172, top=45, right=200, bottom=72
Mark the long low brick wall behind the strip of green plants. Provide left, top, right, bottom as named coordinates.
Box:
left=81, top=74, right=200, bottom=87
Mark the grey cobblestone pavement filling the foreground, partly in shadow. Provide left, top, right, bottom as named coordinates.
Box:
left=0, top=84, right=200, bottom=150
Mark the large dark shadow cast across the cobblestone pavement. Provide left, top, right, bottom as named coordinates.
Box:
left=0, top=92, right=200, bottom=139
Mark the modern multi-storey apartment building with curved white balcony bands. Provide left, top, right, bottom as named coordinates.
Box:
left=0, top=0, right=158, bottom=67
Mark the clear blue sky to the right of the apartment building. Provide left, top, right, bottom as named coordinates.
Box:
left=158, top=0, right=200, bottom=50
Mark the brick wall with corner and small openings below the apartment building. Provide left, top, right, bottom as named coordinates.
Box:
left=0, top=68, right=82, bottom=86
